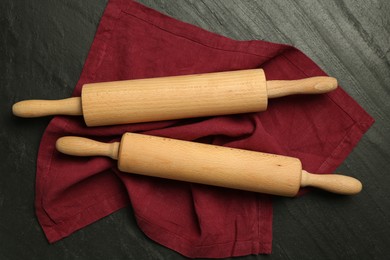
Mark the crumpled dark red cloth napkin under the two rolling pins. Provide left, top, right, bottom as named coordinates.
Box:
left=35, top=0, right=373, bottom=257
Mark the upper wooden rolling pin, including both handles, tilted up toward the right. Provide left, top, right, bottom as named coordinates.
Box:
left=12, top=69, right=337, bottom=126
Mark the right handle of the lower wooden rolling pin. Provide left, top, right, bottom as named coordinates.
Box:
left=301, top=170, right=362, bottom=195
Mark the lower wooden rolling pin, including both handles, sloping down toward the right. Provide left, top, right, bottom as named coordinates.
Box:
left=56, top=133, right=362, bottom=197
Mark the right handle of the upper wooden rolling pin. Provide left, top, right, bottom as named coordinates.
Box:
left=267, top=77, right=337, bottom=98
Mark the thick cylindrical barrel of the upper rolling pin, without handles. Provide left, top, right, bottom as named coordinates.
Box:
left=81, top=69, right=267, bottom=126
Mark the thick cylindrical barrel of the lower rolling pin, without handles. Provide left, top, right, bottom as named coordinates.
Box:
left=118, top=133, right=302, bottom=196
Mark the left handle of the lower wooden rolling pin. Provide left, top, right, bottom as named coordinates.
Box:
left=56, top=136, right=119, bottom=160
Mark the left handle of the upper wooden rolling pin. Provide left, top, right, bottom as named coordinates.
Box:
left=12, top=97, right=83, bottom=117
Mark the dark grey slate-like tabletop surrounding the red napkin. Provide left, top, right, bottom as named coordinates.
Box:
left=0, top=0, right=390, bottom=259
